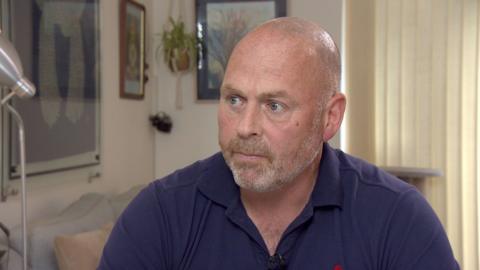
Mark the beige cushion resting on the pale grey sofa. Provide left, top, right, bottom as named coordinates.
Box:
left=54, top=222, right=113, bottom=270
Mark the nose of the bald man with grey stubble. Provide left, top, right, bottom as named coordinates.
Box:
left=237, top=104, right=262, bottom=138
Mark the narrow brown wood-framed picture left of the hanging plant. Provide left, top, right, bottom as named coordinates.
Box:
left=120, top=0, right=145, bottom=99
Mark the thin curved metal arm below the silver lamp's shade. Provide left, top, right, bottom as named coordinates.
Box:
left=2, top=103, right=28, bottom=270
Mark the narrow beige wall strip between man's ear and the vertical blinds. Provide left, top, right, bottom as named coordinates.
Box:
left=344, top=0, right=375, bottom=162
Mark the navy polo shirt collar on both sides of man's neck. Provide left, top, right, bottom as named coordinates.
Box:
left=198, top=143, right=343, bottom=207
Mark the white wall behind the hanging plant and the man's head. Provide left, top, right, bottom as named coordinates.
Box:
left=153, top=0, right=343, bottom=177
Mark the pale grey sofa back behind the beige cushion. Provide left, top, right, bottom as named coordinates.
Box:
left=11, top=193, right=114, bottom=270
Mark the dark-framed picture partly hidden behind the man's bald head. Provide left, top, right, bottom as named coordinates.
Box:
left=196, top=0, right=286, bottom=100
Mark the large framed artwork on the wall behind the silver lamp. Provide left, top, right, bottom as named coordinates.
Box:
left=2, top=0, right=101, bottom=179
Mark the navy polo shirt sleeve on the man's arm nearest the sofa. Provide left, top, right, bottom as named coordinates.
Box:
left=97, top=184, right=171, bottom=270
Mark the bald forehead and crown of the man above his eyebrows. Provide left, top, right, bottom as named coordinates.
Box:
left=224, top=18, right=336, bottom=101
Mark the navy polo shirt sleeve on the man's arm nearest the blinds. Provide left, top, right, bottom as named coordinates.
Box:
left=378, top=189, right=460, bottom=270
